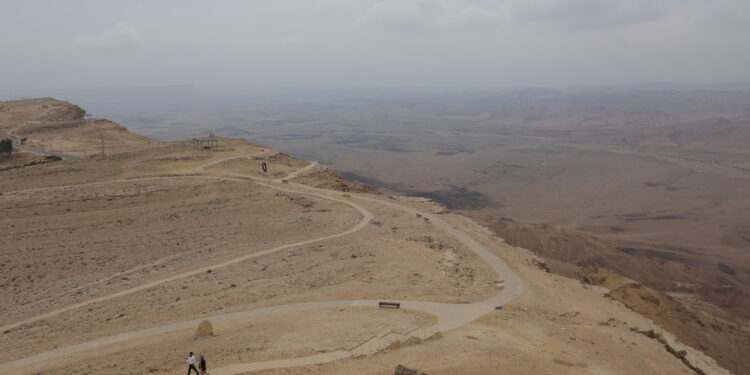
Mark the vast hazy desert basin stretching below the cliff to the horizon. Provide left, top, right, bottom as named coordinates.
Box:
left=30, top=87, right=750, bottom=373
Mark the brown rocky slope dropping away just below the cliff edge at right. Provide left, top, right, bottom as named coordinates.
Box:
left=488, top=218, right=750, bottom=373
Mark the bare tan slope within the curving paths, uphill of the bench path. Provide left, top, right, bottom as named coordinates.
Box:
left=0, top=142, right=506, bottom=370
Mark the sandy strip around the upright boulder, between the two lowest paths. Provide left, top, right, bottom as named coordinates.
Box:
left=11, top=308, right=433, bottom=374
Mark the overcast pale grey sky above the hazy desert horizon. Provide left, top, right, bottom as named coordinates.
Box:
left=0, top=0, right=750, bottom=88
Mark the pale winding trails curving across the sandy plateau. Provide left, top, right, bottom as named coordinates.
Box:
left=0, top=151, right=525, bottom=375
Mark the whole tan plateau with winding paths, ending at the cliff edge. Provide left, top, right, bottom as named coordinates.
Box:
left=0, top=98, right=740, bottom=374
